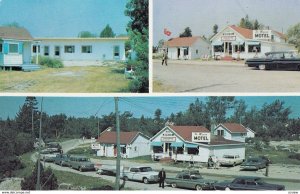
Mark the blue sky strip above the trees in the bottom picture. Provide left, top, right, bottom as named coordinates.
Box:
left=0, top=96, right=300, bottom=119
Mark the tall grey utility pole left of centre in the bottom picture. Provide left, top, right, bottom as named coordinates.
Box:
left=115, top=97, right=121, bottom=190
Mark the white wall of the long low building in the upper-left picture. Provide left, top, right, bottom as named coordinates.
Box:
left=36, top=39, right=126, bottom=61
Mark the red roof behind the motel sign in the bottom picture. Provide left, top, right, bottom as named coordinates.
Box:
left=169, top=126, right=210, bottom=141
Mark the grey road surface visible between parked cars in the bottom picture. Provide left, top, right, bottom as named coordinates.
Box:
left=32, top=139, right=300, bottom=190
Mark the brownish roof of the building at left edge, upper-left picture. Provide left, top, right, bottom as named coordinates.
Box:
left=0, top=27, right=33, bottom=40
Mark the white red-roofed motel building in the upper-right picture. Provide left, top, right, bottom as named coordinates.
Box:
left=210, top=25, right=295, bottom=59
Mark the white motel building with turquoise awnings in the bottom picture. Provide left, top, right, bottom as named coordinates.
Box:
left=150, top=126, right=245, bottom=162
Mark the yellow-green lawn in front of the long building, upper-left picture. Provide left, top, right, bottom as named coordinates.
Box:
left=0, top=64, right=129, bottom=93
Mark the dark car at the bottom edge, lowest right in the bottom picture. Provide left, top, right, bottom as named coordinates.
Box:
left=214, top=176, right=285, bottom=190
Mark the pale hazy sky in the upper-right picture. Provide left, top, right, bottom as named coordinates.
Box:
left=153, top=0, right=300, bottom=45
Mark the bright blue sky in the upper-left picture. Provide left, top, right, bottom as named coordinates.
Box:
left=0, top=0, right=130, bottom=37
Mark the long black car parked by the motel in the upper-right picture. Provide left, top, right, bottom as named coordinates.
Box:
left=245, top=51, right=300, bottom=70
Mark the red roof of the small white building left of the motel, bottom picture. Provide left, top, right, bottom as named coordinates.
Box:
left=97, top=131, right=149, bottom=144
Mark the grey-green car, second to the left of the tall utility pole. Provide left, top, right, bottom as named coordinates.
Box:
left=67, top=155, right=95, bottom=172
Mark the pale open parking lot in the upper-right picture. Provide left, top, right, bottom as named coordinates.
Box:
left=153, top=60, right=300, bottom=93
